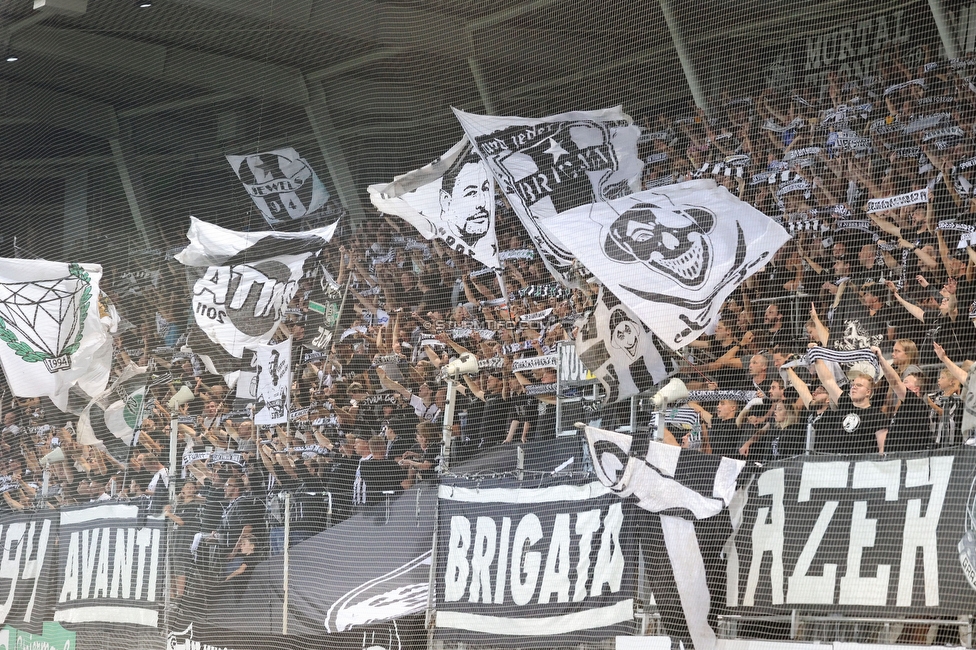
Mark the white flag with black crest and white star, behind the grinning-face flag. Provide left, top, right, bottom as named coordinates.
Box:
left=454, top=106, right=644, bottom=279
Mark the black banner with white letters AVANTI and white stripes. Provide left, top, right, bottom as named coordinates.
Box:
left=54, top=503, right=166, bottom=627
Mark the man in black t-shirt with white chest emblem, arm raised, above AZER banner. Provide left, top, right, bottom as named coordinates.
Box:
left=817, top=359, right=885, bottom=454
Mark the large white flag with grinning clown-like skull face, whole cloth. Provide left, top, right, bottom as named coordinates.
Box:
left=546, top=179, right=790, bottom=350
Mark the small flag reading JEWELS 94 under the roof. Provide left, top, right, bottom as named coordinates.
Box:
left=227, top=147, right=329, bottom=226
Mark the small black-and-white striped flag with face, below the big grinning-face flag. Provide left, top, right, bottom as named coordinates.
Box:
left=576, top=287, right=668, bottom=402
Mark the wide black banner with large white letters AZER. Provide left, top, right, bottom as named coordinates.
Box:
left=713, top=447, right=976, bottom=618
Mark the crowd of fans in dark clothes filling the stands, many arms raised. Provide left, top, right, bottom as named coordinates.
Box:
left=0, top=45, right=976, bottom=612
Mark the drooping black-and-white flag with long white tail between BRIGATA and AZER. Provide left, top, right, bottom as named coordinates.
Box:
left=586, top=426, right=745, bottom=650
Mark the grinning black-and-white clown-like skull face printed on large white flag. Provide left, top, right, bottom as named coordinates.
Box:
left=603, top=203, right=715, bottom=289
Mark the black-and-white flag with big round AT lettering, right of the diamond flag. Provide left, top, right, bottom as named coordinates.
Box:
left=176, top=218, right=336, bottom=386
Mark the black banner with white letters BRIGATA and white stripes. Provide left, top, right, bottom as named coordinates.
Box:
left=436, top=480, right=636, bottom=647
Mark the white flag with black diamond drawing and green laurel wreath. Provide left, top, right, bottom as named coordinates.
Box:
left=0, top=258, right=113, bottom=411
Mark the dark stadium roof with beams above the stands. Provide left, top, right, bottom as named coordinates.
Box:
left=0, top=0, right=963, bottom=258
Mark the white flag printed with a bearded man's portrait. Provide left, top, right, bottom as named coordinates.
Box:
left=368, top=138, right=499, bottom=268
